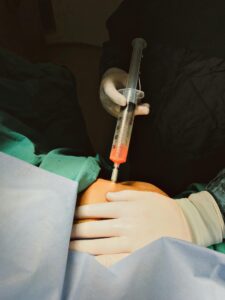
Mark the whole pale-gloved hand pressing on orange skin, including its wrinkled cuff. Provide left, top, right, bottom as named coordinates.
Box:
left=70, top=190, right=224, bottom=265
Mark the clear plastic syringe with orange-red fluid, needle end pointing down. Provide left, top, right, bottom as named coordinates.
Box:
left=110, top=38, right=147, bottom=182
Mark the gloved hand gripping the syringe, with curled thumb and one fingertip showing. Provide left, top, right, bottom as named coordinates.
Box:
left=100, top=68, right=149, bottom=117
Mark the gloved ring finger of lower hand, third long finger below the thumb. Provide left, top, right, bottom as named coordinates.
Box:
left=70, top=237, right=130, bottom=255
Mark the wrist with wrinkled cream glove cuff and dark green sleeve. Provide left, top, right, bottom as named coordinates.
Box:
left=177, top=169, right=225, bottom=246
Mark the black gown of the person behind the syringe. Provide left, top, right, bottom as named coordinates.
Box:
left=100, top=0, right=225, bottom=203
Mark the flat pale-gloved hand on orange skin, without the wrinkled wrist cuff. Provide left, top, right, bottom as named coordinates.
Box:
left=70, top=190, right=192, bottom=255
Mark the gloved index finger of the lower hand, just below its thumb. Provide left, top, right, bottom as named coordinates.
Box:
left=76, top=202, right=122, bottom=219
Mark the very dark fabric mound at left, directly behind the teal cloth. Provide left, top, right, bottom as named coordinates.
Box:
left=0, top=49, right=94, bottom=156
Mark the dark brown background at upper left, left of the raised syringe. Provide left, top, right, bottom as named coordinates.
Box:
left=0, top=0, right=121, bottom=157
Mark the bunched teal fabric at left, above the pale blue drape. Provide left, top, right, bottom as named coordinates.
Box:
left=0, top=112, right=100, bottom=192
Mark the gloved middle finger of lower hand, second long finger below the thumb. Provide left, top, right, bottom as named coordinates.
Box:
left=71, top=219, right=121, bottom=239
